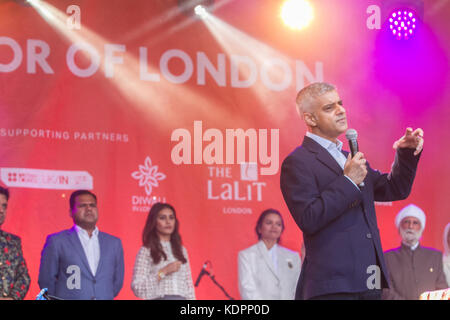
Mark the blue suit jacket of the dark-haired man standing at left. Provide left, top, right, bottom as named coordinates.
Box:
left=38, top=227, right=124, bottom=300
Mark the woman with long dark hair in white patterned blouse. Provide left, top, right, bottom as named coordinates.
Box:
left=131, top=202, right=195, bottom=300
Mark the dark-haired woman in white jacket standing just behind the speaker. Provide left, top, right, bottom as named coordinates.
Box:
left=238, top=209, right=301, bottom=300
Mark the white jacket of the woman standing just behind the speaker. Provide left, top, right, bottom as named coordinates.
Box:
left=238, top=241, right=301, bottom=300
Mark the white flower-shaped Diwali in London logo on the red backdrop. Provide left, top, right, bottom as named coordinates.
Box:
left=131, top=156, right=166, bottom=212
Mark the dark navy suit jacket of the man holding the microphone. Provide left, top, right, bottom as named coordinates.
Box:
left=280, top=137, right=419, bottom=299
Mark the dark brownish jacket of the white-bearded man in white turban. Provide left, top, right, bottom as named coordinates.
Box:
left=383, top=244, right=450, bottom=300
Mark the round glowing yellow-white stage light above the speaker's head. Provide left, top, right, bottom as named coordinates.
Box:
left=281, top=0, right=314, bottom=30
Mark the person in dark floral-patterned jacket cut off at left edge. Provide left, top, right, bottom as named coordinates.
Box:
left=0, top=187, right=30, bottom=300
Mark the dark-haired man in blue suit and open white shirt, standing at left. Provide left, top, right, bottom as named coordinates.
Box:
left=38, top=190, right=124, bottom=300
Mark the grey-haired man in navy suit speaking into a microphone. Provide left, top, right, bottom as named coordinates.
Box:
left=280, top=83, right=423, bottom=300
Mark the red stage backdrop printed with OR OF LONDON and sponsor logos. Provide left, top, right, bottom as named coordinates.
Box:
left=0, top=0, right=450, bottom=299
